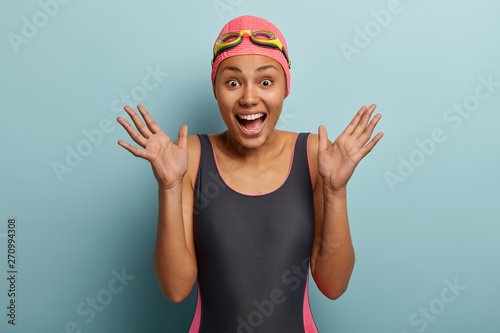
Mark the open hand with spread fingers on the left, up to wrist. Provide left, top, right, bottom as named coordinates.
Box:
left=117, top=105, right=188, bottom=189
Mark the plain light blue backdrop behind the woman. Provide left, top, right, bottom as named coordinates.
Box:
left=0, top=0, right=500, bottom=333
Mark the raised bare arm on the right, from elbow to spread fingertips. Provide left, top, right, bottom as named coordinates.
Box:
left=311, top=105, right=384, bottom=299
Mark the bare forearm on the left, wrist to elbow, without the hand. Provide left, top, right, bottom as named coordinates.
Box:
left=153, top=185, right=196, bottom=302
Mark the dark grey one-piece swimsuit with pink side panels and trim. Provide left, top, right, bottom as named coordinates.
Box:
left=189, top=133, right=317, bottom=333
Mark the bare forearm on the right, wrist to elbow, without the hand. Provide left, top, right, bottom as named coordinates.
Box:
left=313, top=187, right=354, bottom=299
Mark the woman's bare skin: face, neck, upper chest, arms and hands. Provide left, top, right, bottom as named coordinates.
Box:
left=117, top=55, right=383, bottom=302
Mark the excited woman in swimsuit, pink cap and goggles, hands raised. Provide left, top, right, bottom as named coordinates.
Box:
left=117, top=16, right=383, bottom=333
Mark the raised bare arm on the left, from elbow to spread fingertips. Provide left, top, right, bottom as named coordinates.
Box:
left=117, top=105, right=197, bottom=303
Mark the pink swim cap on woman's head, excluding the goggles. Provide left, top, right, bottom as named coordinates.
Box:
left=212, top=15, right=290, bottom=98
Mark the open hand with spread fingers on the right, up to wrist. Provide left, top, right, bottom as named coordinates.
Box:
left=318, top=104, right=384, bottom=192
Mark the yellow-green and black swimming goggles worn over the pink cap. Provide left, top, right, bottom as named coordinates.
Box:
left=212, top=30, right=292, bottom=68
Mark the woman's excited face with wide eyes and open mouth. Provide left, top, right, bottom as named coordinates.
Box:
left=215, top=55, right=286, bottom=149
